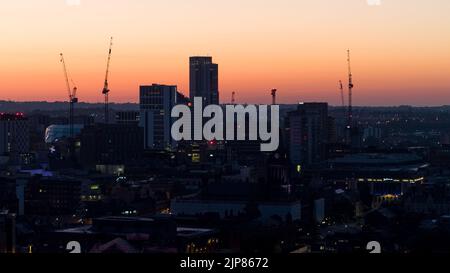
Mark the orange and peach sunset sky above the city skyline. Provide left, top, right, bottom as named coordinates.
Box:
left=0, top=0, right=450, bottom=106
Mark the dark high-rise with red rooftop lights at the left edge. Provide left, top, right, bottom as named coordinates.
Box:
left=0, top=113, right=30, bottom=160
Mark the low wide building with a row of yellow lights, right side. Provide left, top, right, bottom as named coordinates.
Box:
left=317, top=153, right=430, bottom=207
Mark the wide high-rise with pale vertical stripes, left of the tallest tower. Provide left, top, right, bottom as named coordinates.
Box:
left=139, top=84, right=186, bottom=149
